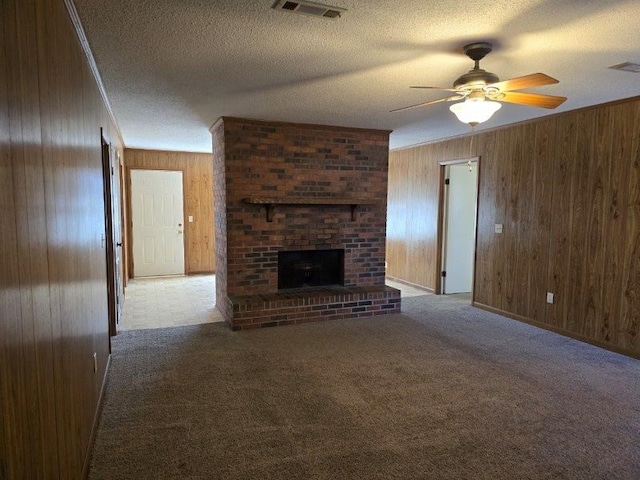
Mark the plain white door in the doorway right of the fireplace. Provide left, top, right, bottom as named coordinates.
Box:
left=442, top=162, right=478, bottom=293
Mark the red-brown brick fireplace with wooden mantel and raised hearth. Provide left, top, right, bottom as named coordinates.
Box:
left=211, top=117, right=400, bottom=330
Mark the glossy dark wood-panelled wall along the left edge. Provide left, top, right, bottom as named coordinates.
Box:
left=0, top=0, right=119, bottom=479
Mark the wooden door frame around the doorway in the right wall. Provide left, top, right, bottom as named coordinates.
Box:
left=435, top=156, right=482, bottom=296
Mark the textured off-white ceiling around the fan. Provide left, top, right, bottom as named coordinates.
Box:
left=75, top=0, right=640, bottom=152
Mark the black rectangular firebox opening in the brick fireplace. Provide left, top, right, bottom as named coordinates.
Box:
left=278, top=249, right=344, bottom=289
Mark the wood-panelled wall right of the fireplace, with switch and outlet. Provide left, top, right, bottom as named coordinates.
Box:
left=387, top=98, right=640, bottom=356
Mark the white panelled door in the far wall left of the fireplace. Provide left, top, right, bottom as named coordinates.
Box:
left=131, top=170, right=184, bottom=277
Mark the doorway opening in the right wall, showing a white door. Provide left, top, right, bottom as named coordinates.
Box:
left=437, top=157, right=479, bottom=301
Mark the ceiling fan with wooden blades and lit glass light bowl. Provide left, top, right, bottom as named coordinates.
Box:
left=391, top=42, right=567, bottom=127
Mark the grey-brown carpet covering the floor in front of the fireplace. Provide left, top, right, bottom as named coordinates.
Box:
left=90, top=295, right=640, bottom=480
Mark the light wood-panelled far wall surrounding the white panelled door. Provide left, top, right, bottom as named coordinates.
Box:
left=124, top=148, right=216, bottom=274
